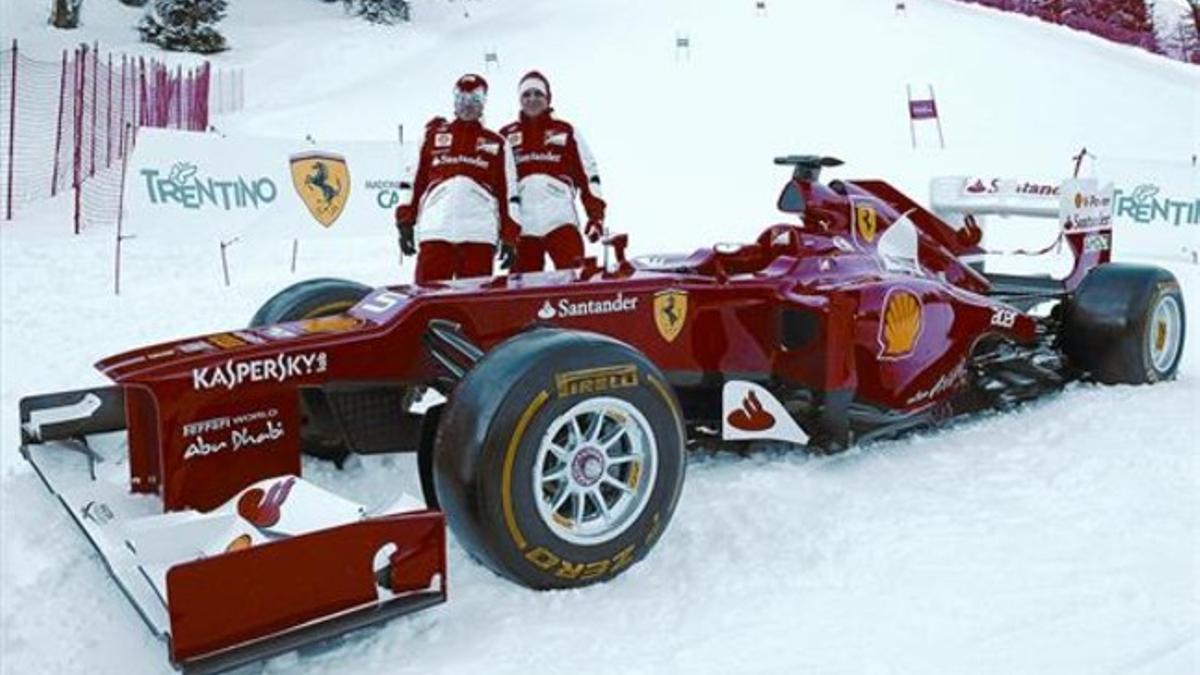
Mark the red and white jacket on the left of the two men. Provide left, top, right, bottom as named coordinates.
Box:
left=396, top=118, right=521, bottom=245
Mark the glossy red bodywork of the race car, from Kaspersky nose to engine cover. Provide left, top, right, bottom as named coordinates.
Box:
left=97, top=172, right=1036, bottom=510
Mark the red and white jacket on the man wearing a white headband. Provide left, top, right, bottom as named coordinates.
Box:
left=500, top=110, right=605, bottom=237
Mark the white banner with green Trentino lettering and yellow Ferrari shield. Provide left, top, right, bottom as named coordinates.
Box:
left=124, top=129, right=415, bottom=241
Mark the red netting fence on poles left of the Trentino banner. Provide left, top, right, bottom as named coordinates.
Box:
left=0, top=41, right=244, bottom=227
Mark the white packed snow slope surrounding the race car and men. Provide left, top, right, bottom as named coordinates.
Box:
left=0, top=0, right=1200, bottom=674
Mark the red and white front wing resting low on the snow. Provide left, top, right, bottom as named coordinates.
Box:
left=20, top=387, right=446, bottom=673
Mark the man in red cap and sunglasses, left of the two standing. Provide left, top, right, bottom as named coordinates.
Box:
left=396, top=74, right=521, bottom=283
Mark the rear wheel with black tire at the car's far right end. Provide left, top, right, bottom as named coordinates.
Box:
left=1063, top=263, right=1187, bottom=384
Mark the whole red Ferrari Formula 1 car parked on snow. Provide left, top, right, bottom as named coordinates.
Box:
left=20, top=156, right=1184, bottom=670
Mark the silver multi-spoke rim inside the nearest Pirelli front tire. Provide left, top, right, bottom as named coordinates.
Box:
left=533, top=396, right=659, bottom=545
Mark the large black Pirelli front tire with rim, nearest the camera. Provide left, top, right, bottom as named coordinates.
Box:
left=433, top=328, right=685, bottom=589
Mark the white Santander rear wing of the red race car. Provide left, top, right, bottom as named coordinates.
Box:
left=929, top=175, right=1115, bottom=291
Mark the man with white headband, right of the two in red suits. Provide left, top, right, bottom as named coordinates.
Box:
left=500, top=71, right=605, bottom=271
